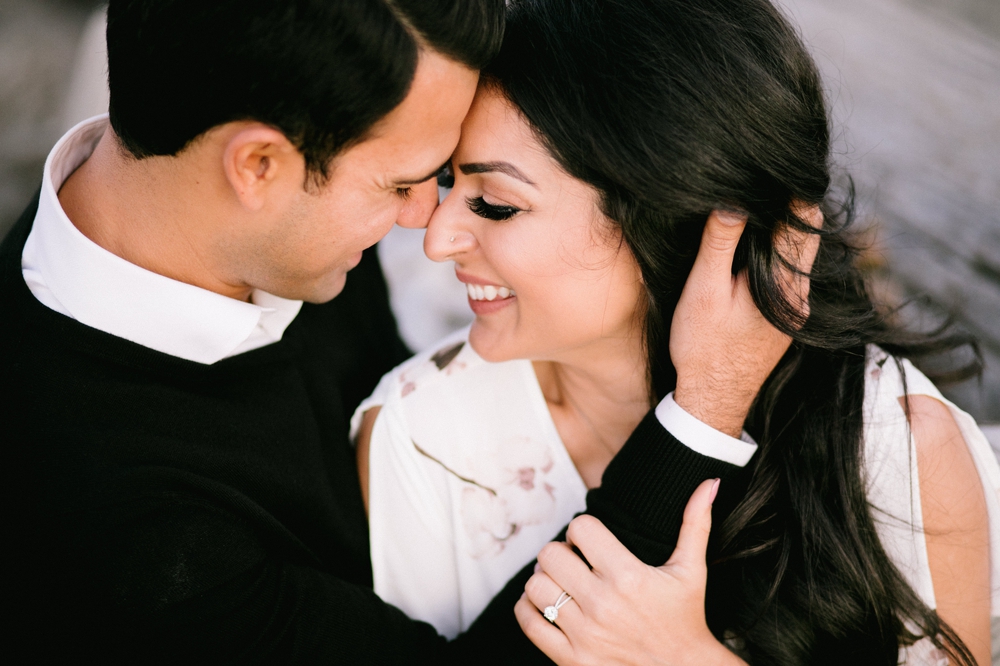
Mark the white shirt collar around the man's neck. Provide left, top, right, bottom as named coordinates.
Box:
left=21, top=114, right=302, bottom=364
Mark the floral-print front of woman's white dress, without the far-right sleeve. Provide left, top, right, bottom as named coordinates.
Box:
left=351, top=330, right=587, bottom=637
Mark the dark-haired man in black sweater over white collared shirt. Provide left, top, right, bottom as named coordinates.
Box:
left=0, top=0, right=787, bottom=664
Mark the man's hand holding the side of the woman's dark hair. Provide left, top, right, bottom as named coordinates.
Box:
left=670, top=206, right=823, bottom=437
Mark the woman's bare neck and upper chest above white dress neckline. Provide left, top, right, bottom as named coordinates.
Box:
left=533, top=337, right=650, bottom=488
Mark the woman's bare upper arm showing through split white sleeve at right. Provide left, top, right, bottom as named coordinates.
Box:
left=909, top=395, right=991, bottom=664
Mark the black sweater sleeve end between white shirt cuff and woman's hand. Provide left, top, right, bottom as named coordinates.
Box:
left=587, top=411, right=743, bottom=565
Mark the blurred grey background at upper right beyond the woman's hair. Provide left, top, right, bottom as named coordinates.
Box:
left=782, top=0, right=1000, bottom=422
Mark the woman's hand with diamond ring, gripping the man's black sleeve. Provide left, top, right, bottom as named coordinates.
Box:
left=514, top=480, right=744, bottom=666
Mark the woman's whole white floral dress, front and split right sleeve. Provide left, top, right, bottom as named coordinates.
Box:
left=351, top=330, right=1000, bottom=666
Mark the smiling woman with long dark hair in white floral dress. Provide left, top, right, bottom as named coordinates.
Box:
left=354, top=0, right=1000, bottom=664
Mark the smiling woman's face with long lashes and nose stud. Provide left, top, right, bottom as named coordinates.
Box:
left=424, top=86, right=642, bottom=362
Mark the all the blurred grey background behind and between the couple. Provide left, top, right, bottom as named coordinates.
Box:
left=0, top=0, right=1000, bottom=426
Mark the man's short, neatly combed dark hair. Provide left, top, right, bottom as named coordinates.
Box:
left=108, top=0, right=505, bottom=178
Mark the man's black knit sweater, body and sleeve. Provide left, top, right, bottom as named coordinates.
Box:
left=0, top=191, right=748, bottom=664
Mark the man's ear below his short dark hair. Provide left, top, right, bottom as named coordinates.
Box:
left=222, top=123, right=305, bottom=212
